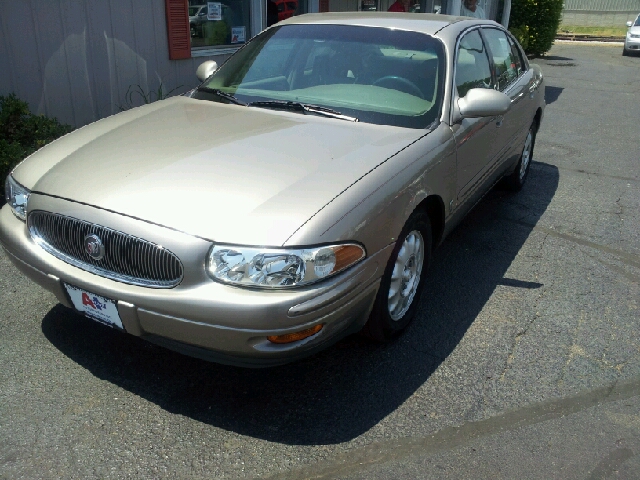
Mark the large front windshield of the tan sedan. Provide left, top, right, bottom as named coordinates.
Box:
left=194, top=25, right=444, bottom=128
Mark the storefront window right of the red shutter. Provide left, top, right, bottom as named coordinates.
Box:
left=189, top=0, right=251, bottom=48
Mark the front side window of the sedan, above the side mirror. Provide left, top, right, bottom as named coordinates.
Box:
left=455, top=30, right=493, bottom=98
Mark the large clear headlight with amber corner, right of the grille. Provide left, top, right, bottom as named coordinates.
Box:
left=207, top=243, right=366, bottom=288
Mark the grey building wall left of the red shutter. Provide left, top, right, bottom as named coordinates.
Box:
left=0, top=0, right=226, bottom=127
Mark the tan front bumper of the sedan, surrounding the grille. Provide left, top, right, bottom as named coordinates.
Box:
left=0, top=194, right=384, bottom=367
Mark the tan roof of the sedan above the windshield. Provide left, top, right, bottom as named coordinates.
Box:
left=278, top=12, right=478, bottom=35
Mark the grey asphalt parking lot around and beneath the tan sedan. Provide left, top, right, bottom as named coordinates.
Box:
left=0, top=43, right=640, bottom=479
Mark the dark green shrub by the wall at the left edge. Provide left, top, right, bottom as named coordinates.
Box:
left=0, top=94, right=73, bottom=197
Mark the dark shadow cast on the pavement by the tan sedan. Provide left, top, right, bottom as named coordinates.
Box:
left=42, top=162, right=558, bottom=445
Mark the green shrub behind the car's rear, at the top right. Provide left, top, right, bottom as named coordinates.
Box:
left=509, top=0, right=563, bottom=56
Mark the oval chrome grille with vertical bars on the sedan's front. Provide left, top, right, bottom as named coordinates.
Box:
left=28, top=211, right=182, bottom=288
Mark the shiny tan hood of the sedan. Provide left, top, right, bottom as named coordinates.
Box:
left=14, top=97, right=425, bottom=245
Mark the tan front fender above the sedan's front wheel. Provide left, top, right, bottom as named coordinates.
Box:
left=285, top=124, right=456, bottom=255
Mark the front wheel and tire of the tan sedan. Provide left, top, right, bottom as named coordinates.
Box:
left=362, top=211, right=432, bottom=342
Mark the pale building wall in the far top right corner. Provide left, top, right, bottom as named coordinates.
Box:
left=561, top=0, right=640, bottom=27
